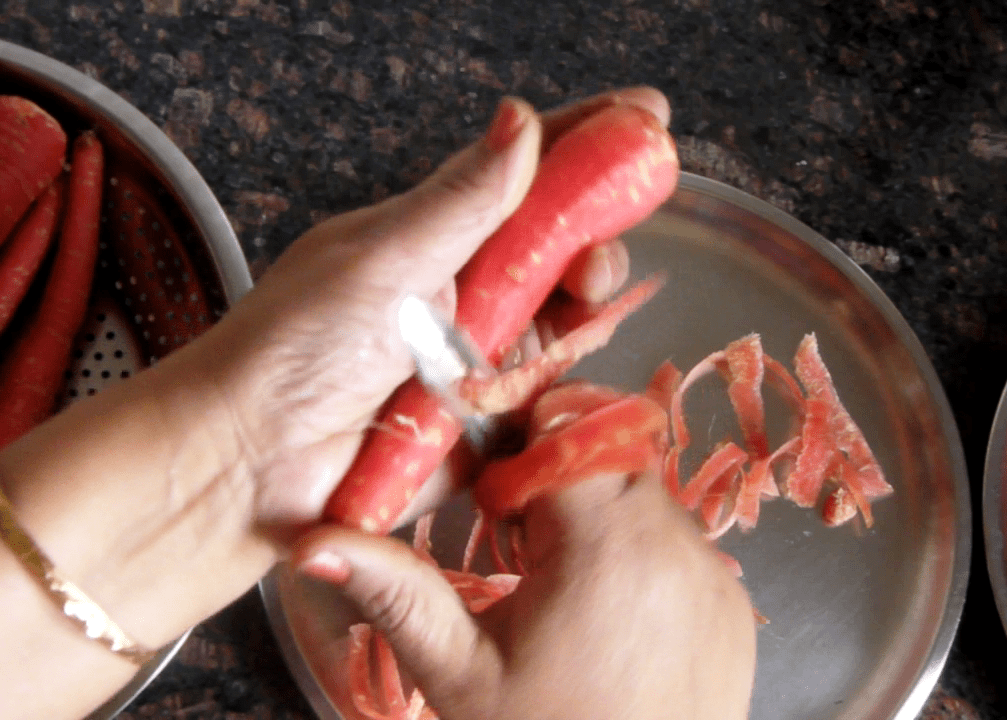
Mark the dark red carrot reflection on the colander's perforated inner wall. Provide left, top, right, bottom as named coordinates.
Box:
left=102, top=173, right=215, bottom=359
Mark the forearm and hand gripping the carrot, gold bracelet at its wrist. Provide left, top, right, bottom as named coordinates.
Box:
left=0, top=90, right=669, bottom=718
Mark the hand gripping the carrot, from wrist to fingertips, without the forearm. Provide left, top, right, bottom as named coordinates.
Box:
left=198, top=89, right=670, bottom=529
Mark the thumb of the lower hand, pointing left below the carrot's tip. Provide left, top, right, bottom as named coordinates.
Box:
left=291, top=526, right=501, bottom=717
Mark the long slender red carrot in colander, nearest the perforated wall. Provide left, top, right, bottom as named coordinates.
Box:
left=0, top=133, right=104, bottom=447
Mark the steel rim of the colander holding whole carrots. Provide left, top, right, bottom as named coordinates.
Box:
left=0, top=39, right=252, bottom=720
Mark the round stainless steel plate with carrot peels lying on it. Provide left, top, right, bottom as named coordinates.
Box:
left=262, top=175, right=970, bottom=720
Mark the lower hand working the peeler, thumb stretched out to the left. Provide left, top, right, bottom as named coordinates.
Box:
left=292, top=467, right=755, bottom=720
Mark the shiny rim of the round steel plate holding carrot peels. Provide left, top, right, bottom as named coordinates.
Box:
left=259, top=172, right=974, bottom=720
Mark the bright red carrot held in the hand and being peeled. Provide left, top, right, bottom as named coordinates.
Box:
left=325, top=104, right=679, bottom=533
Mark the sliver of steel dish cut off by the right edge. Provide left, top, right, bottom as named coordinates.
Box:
left=983, top=386, right=1007, bottom=631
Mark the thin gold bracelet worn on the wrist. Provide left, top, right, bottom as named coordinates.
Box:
left=0, top=492, right=157, bottom=666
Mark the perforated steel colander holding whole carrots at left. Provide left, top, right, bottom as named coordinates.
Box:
left=0, top=40, right=252, bottom=720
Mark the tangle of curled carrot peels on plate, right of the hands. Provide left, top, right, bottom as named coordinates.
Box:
left=661, top=333, right=892, bottom=539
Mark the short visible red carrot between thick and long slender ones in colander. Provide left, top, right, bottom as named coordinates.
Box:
left=0, top=181, right=62, bottom=332
